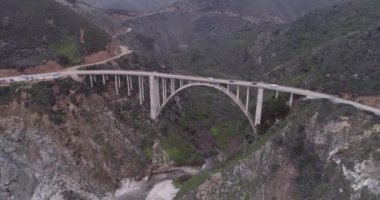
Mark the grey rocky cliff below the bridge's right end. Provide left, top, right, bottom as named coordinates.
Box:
left=180, top=102, right=380, bottom=200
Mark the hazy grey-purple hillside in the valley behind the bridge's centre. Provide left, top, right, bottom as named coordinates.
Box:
left=121, top=12, right=260, bottom=76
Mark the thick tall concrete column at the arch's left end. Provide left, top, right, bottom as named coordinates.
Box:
left=149, top=76, right=160, bottom=119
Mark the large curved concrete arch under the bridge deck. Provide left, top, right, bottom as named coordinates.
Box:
left=154, top=83, right=255, bottom=131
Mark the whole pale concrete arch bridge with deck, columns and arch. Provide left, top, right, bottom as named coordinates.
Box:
left=59, top=70, right=380, bottom=132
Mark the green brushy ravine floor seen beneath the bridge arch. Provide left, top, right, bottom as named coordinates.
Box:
left=161, top=87, right=252, bottom=166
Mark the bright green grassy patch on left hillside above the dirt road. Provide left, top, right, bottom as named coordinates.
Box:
left=51, top=39, right=81, bottom=65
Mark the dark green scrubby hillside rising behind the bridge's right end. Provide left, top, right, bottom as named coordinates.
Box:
left=252, top=0, right=380, bottom=95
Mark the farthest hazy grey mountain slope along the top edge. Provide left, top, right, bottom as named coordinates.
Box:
left=175, top=0, right=347, bottom=23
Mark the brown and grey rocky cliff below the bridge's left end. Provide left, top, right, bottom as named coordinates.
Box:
left=0, top=81, right=154, bottom=200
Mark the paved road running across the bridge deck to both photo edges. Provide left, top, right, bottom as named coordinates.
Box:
left=0, top=70, right=380, bottom=115
